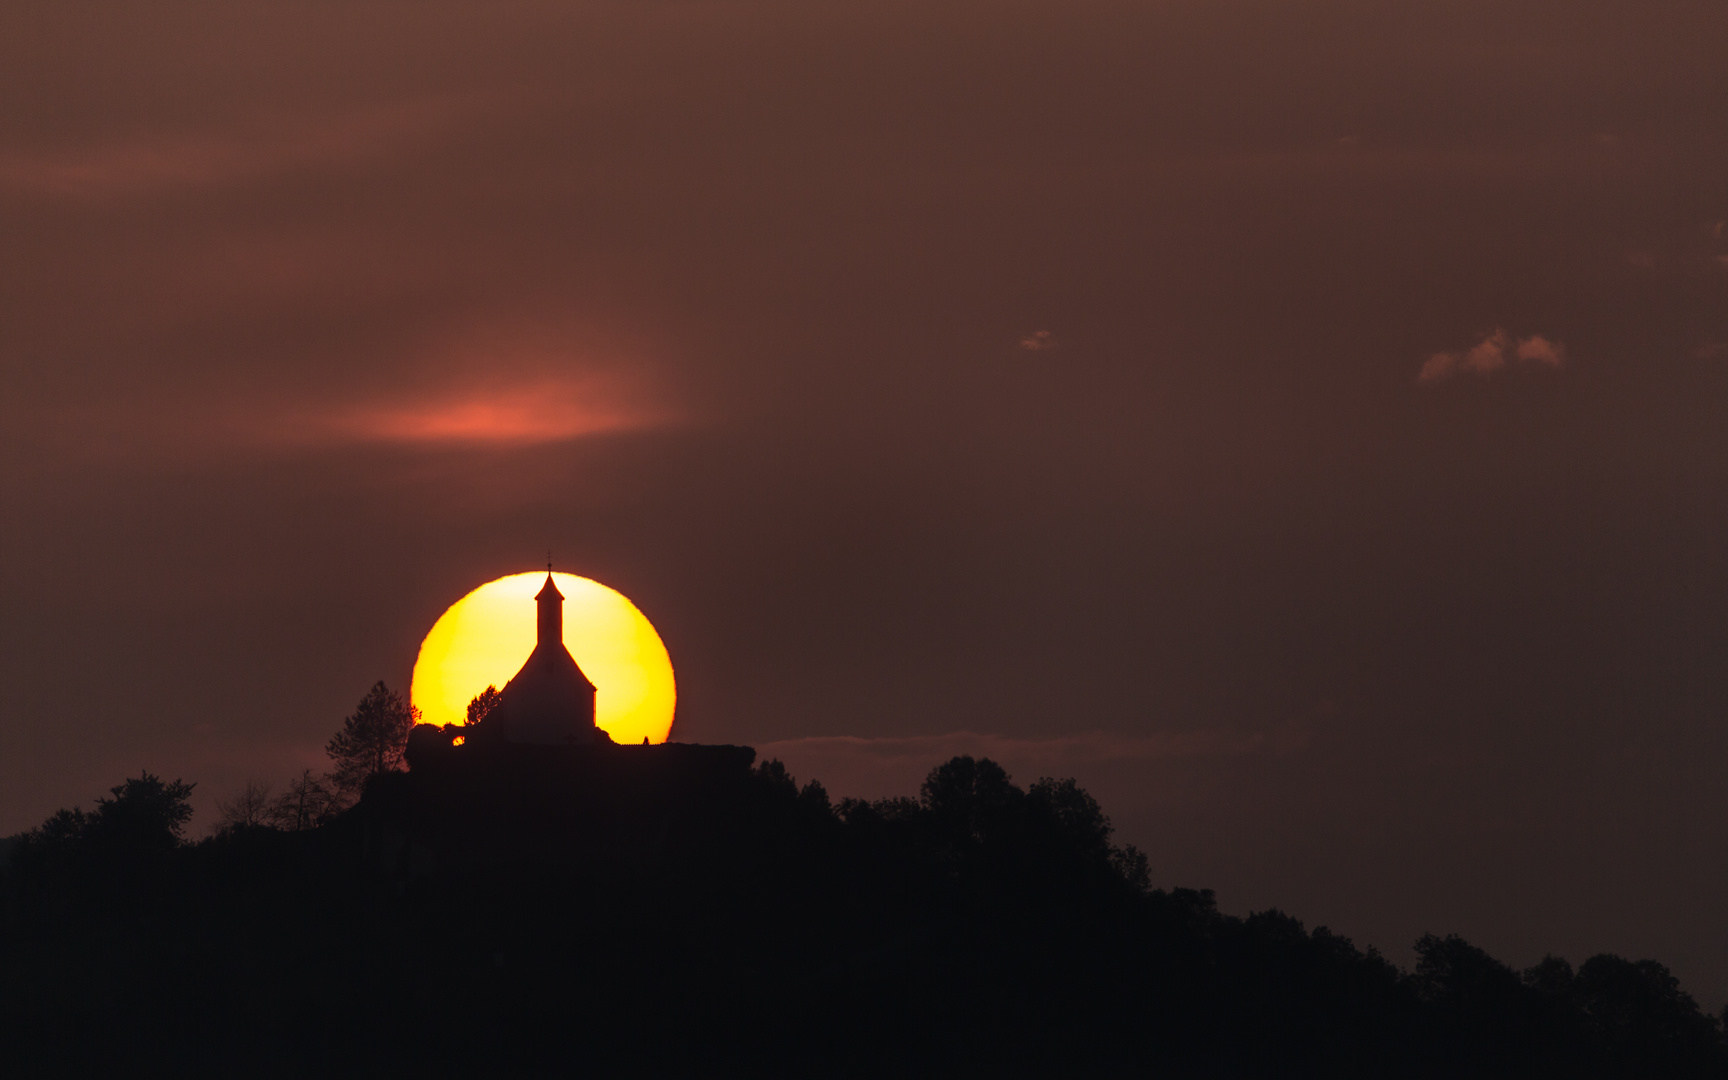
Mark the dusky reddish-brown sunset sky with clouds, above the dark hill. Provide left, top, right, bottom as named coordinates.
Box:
left=0, top=0, right=1728, bottom=1007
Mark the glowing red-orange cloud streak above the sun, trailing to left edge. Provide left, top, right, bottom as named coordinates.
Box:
left=5, top=304, right=691, bottom=463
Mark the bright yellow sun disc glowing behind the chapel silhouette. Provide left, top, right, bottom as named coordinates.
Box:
left=410, top=570, right=677, bottom=745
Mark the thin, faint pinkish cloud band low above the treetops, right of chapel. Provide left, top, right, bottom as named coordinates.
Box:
left=757, top=724, right=1308, bottom=798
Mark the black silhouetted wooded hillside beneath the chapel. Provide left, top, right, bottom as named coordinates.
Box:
left=0, top=746, right=1728, bottom=1077
